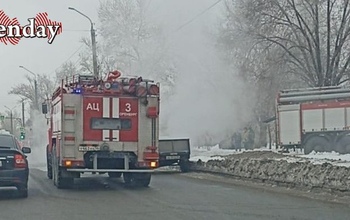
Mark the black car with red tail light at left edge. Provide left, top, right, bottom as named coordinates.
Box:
left=0, top=133, right=31, bottom=198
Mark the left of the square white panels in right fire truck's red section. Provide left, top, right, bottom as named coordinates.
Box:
left=302, top=109, right=323, bottom=132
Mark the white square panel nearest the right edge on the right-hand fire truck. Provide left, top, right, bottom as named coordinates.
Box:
left=324, top=108, right=345, bottom=131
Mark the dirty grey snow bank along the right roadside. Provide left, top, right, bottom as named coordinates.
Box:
left=191, top=147, right=350, bottom=191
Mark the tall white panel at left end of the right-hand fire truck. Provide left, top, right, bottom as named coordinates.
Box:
left=279, top=105, right=301, bottom=145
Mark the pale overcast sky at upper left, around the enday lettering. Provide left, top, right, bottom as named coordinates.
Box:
left=0, top=0, right=99, bottom=111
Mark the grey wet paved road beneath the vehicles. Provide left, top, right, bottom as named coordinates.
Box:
left=0, top=169, right=350, bottom=220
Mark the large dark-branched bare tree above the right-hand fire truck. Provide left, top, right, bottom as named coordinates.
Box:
left=228, top=0, right=350, bottom=86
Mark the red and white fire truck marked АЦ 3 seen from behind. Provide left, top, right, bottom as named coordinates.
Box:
left=42, top=71, right=160, bottom=188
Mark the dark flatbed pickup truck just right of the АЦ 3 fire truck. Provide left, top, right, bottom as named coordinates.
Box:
left=159, top=138, right=191, bottom=172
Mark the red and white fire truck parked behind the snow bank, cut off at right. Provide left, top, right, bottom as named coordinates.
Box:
left=276, top=86, right=350, bottom=154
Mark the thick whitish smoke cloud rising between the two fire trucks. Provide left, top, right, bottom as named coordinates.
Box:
left=154, top=0, right=254, bottom=145
